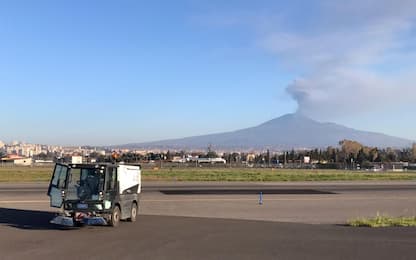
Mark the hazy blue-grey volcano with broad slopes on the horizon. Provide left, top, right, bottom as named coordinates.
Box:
left=118, top=114, right=413, bottom=150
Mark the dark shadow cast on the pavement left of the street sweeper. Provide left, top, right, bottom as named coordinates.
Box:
left=0, top=208, right=70, bottom=230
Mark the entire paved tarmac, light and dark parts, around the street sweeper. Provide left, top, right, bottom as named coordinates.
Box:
left=0, top=181, right=416, bottom=259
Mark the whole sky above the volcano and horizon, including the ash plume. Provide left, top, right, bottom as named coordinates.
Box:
left=0, top=0, right=416, bottom=145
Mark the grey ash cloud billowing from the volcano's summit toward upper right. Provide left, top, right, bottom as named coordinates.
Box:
left=260, top=0, right=416, bottom=119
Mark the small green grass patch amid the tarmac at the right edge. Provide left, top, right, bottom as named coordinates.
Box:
left=348, top=213, right=416, bottom=228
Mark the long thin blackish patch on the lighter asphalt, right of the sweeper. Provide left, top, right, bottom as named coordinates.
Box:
left=160, top=189, right=336, bottom=195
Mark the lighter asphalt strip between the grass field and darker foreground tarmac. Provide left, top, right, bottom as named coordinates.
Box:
left=0, top=181, right=416, bottom=224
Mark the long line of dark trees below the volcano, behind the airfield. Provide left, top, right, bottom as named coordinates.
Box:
left=29, top=140, right=416, bottom=168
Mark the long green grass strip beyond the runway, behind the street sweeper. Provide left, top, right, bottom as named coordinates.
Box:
left=0, top=167, right=416, bottom=182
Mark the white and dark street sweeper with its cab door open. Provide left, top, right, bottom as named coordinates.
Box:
left=48, top=163, right=141, bottom=227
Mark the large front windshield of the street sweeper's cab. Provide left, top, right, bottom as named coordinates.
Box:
left=66, top=168, right=104, bottom=201
